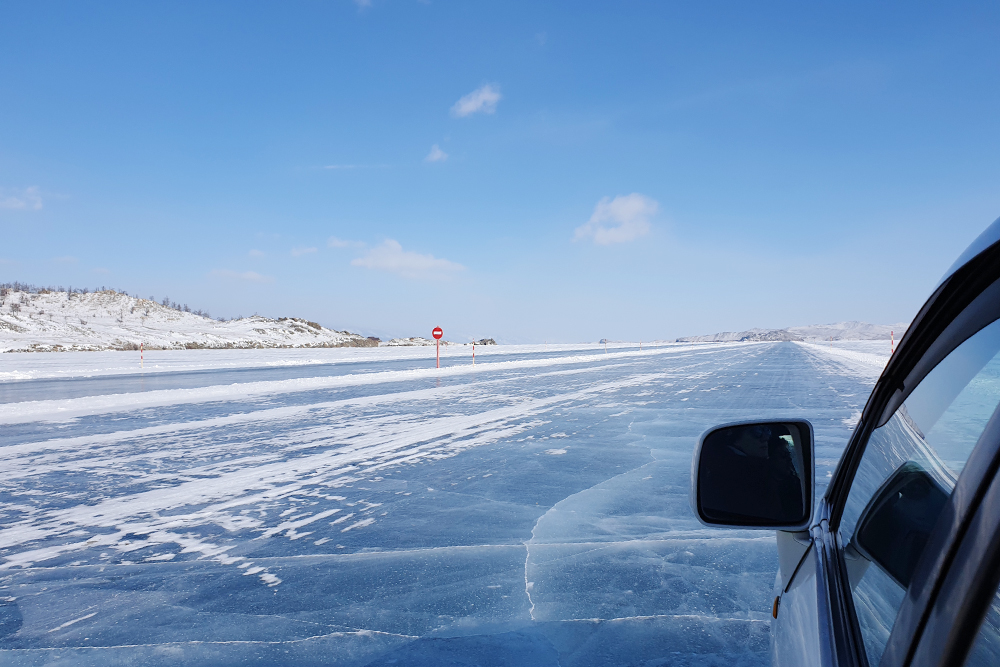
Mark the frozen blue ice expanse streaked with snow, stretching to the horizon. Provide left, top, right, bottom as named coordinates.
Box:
left=0, top=342, right=888, bottom=667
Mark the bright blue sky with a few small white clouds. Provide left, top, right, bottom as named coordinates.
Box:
left=0, top=0, right=1000, bottom=342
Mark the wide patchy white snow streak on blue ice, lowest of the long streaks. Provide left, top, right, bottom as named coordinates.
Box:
left=0, top=373, right=662, bottom=570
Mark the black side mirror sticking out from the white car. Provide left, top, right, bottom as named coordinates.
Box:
left=691, top=419, right=814, bottom=531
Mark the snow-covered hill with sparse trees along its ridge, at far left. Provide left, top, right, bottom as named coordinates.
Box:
left=0, top=289, right=379, bottom=352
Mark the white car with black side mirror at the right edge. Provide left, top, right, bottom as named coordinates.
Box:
left=691, top=220, right=1000, bottom=667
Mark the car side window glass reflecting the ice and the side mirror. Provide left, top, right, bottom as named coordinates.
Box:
left=840, top=321, right=1000, bottom=665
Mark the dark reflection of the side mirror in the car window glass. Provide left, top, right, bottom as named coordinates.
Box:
left=851, top=461, right=948, bottom=588
